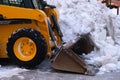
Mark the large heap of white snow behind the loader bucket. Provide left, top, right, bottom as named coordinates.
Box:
left=47, top=0, right=120, bottom=73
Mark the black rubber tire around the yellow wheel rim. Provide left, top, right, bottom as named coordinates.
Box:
left=7, top=28, right=47, bottom=68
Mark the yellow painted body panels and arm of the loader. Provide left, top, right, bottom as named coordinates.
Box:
left=0, top=5, right=60, bottom=58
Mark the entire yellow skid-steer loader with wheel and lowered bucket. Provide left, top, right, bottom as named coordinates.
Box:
left=0, top=0, right=95, bottom=75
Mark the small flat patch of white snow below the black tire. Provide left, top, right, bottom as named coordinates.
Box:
left=0, top=66, right=28, bottom=78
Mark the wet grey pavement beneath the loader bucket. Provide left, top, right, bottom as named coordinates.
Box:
left=0, top=60, right=120, bottom=80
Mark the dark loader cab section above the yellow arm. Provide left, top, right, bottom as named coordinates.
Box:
left=0, top=0, right=43, bottom=9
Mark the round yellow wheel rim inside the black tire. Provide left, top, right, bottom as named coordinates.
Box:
left=14, top=37, right=37, bottom=61
